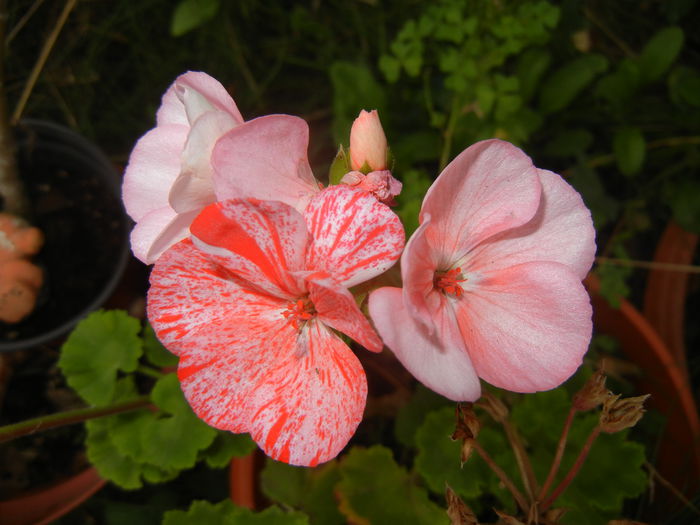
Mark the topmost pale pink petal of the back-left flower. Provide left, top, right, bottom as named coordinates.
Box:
left=156, top=71, right=243, bottom=126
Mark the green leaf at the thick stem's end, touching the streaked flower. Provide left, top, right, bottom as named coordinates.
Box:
left=141, top=374, right=216, bottom=469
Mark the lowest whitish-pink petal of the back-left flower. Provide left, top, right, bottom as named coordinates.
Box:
left=126, top=206, right=197, bottom=264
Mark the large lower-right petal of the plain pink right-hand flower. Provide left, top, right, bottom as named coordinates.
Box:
left=456, top=262, right=592, bottom=392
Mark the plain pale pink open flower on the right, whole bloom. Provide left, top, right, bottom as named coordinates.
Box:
left=369, top=140, right=595, bottom=401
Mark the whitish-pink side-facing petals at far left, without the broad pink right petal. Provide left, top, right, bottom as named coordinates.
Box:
left=122, top=71, right=243, bottom=264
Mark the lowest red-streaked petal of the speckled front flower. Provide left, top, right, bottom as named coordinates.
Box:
left=246, top=322, right=367, bottom=466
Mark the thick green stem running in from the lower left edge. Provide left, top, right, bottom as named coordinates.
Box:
left=0, top=395, right=151, bottom=443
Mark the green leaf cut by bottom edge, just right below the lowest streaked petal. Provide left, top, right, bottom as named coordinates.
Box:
left=336, top=446, right=449, bottom=525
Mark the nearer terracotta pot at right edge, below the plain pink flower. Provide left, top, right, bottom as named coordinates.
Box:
left=586, top=277, right=700, bottom=509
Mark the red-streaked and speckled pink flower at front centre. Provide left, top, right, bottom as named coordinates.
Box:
left=148, top=186, right=404, bottom=465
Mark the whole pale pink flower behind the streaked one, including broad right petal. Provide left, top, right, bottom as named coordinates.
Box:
left=122, top=72, right=319, bottom=264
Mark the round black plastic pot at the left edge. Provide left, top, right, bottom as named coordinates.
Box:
left=0, top=120, right=130, bottom=352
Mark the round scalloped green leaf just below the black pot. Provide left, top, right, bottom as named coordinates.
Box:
left=58, top=310, right=142, bottom=406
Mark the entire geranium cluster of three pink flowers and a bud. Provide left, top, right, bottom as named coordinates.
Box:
left=123, top=72, right=595, bottom=465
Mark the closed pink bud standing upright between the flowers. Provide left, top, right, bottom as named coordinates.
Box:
left=350, top=109, right=387, bottom=171
